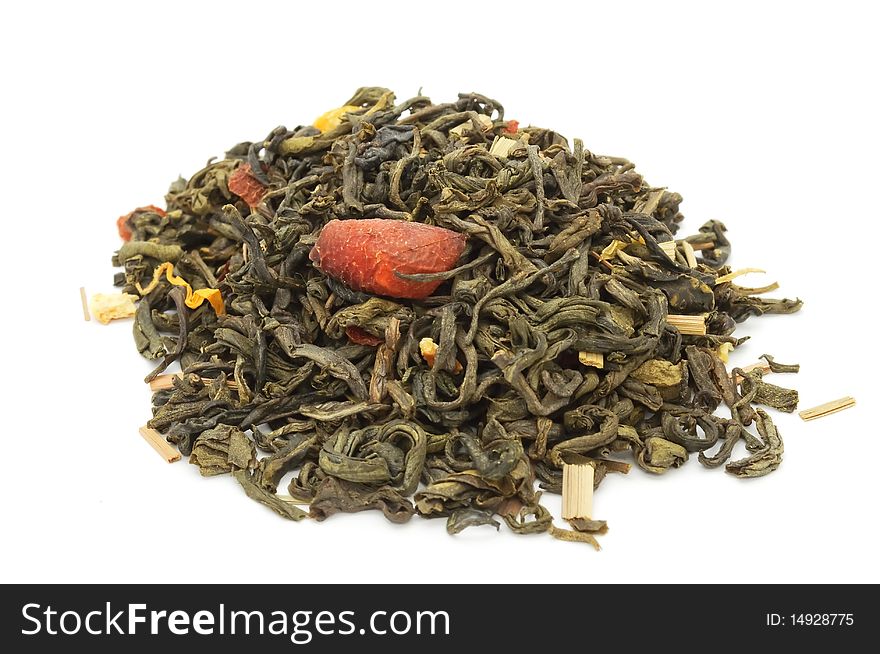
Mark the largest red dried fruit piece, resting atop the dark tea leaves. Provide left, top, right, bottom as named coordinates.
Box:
left=309, top=218, right=465, bottom=300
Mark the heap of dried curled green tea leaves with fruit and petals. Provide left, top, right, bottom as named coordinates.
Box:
left=106, top=87, right=801, bottom=544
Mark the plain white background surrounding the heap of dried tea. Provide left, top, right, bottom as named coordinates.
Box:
left=0, top=0, right=880, bottom=583
